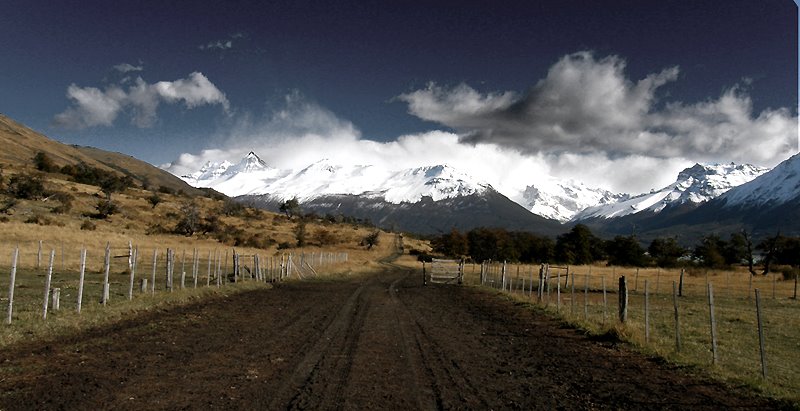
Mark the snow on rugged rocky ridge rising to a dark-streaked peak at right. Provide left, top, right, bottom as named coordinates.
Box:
left=573, top=163, right=769, bottom=220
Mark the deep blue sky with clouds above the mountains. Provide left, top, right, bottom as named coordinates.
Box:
left=0, top=0, right=798, bottom=195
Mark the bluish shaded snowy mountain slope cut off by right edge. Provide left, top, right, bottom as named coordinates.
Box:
left=720, top=154, right=800, bottom=208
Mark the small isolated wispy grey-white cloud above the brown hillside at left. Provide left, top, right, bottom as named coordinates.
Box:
left=53, top=72, right=230, bottom=129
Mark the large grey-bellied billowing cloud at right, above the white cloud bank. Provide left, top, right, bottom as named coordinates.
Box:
left=398, top=52, right=797, bottom=166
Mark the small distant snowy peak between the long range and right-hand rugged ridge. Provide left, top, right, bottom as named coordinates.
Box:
left=512, top=178, right=629, bottom=223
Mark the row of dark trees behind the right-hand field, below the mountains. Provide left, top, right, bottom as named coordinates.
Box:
left=431, top=224, right=800, bottom=274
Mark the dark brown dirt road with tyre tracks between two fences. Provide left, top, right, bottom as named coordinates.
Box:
left=0, top=265, right=780, bottom=410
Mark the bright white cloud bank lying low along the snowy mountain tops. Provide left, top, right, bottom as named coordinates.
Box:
left=163, top=93, right=692, bottom=197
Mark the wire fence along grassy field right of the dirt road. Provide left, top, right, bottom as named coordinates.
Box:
left=465, top=262, right=800, bottom=396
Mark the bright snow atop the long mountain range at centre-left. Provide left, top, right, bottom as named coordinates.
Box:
left=182, top=152, right=491, bottom=204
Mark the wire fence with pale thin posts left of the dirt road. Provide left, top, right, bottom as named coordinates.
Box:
left=0, top=241, right=348, bottom=324
